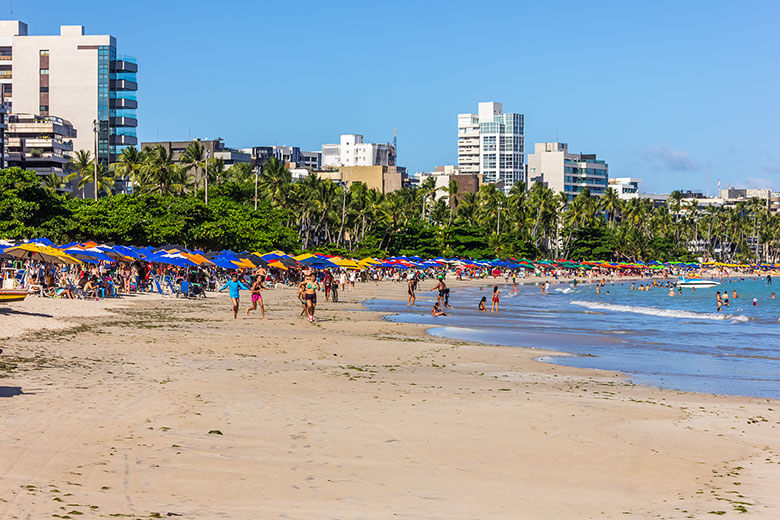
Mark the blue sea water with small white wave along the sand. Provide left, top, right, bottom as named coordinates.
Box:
left=367, top=278, right=780, bottom=399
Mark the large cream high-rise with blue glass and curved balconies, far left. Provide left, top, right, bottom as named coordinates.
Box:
left=0, top=20, right=138, bottom=163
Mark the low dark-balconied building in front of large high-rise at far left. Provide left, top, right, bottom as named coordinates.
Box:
left=5, top=113, right=77, bottom=177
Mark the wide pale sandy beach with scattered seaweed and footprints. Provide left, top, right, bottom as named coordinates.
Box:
left=0, top=281, right=780, bottom=519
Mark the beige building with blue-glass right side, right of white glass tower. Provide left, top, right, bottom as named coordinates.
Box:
left=528, top=143, right=609, bottom=200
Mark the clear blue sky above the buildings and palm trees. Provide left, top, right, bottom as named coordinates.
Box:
left=10, top=0, right=780, bottom=193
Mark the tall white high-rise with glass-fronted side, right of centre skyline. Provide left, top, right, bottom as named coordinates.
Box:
left=458, top=101, right=525, bottom=191
